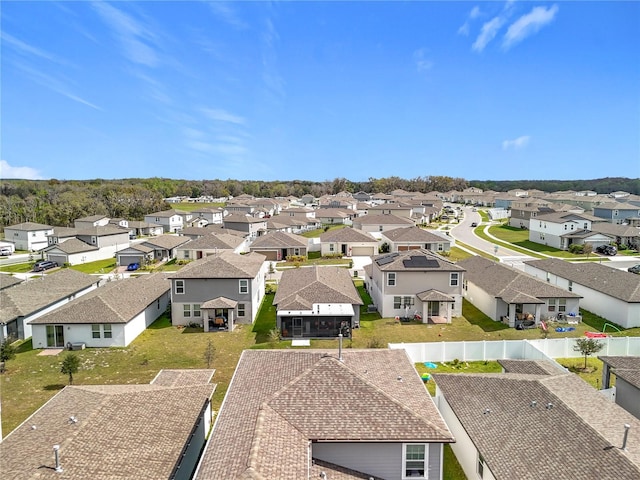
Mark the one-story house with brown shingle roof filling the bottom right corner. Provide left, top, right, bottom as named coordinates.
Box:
left=433, top=361, right=640, bottom=480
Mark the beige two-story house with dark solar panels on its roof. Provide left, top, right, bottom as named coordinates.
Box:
left=365, top=249, right=464, bottom=323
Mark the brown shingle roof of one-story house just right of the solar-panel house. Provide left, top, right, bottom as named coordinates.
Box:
left=458, top=255, right=582, bottom=303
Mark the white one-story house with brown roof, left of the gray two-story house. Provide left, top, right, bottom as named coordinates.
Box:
left=29, top=273, right=170, bottom=348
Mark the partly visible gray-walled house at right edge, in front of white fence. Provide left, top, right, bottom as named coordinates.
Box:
left=598, top=355, right=640, bottom=419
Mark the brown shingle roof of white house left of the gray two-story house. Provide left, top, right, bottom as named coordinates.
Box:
left=29, top=273, right=170, bottom=325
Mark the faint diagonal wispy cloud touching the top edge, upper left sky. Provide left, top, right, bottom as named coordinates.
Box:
left=93, top=2, right=159, bottom=67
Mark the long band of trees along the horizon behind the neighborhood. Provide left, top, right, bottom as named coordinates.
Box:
left=0, top=176, right=640, bottom=226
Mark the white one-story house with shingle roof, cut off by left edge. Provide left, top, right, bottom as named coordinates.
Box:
left=0, top=268, right=101, bottom=340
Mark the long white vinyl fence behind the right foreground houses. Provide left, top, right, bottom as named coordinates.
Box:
left=389, top=337, right=640, bottom=363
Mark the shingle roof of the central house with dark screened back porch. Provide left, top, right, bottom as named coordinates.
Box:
left=273, top=266, right=363, bottom=310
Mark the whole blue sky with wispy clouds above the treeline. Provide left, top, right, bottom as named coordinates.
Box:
left=0, top=1, right=640, bottom=181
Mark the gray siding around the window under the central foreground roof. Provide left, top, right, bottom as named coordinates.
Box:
left=312, top=442, right=442, bottom=480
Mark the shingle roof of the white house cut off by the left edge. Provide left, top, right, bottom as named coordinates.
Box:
left=0, top=268, right=100, bottom=323
